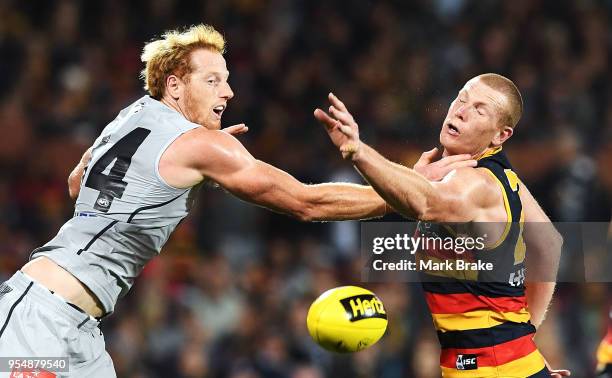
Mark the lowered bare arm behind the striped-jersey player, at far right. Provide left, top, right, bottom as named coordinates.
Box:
left=520, top=185, right=563, bottom=328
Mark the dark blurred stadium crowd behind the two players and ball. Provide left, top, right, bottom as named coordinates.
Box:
left=0, top=0, right=612, bottom=378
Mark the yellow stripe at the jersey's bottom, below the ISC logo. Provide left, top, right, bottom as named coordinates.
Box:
left=442, top=350, right=546, bottom=378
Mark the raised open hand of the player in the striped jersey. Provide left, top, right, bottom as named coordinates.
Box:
left=314, top=93, right=361, bottom=159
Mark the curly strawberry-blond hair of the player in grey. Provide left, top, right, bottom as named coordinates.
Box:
left=140, top=24, right=225, bottom=100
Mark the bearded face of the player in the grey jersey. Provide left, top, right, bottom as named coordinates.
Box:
left=182, top=49, right=234, bottom=130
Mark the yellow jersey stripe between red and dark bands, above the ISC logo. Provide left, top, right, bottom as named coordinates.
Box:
left=431, top=308, right=531, bottom=332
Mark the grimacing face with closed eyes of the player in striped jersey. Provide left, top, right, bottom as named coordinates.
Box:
left=440, top=78, right=506, bottom=156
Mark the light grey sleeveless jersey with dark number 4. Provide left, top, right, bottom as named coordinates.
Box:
left=30, top=96, right=200, bottom=313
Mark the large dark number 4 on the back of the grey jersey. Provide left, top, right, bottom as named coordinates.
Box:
left=85, top=127, right=151, bottom=213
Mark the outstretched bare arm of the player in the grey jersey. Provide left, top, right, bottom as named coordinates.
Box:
left=167, top=129, right=387, bottom=221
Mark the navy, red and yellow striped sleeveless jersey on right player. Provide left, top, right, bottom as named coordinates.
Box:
left=417, top=148, right=550, bottom=378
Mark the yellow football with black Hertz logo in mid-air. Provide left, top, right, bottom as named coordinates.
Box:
left=306, top=286, right=387, bottom=353
